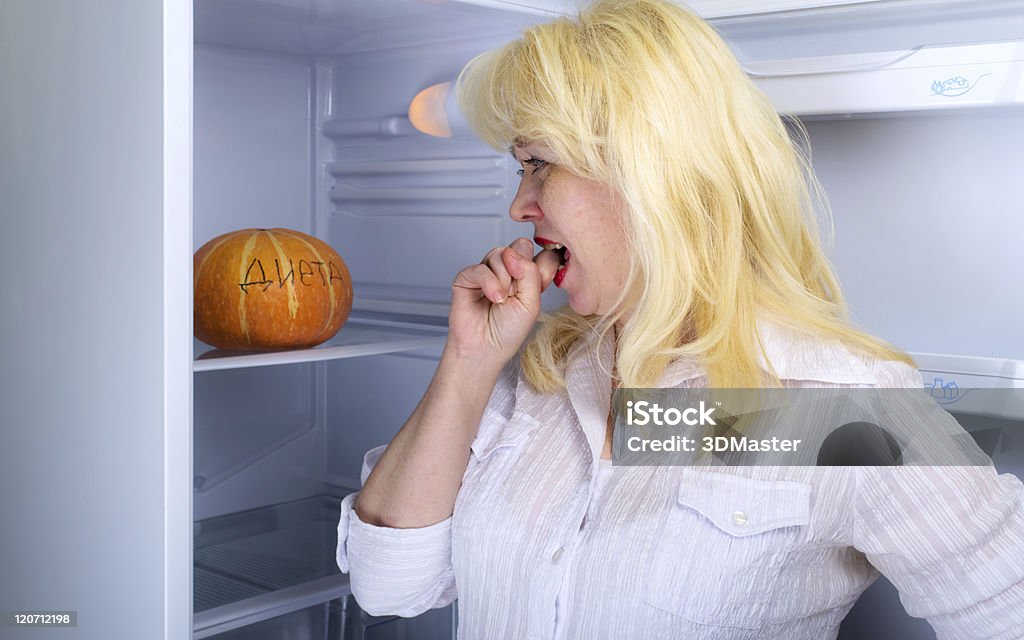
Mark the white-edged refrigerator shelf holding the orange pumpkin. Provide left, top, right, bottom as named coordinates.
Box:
left=193, top=316, right=447, bottom=372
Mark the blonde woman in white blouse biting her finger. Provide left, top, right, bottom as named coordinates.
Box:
left=338, top=0, right=1024, bottom=640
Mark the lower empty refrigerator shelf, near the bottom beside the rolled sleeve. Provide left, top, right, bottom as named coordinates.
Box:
left=193, top=496, right=350, bottom=640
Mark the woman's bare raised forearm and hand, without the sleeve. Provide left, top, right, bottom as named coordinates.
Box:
left=356, top=238, right=558, bottom=527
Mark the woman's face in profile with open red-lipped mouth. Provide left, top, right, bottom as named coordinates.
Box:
left=509, top=142, right=629, bottom=315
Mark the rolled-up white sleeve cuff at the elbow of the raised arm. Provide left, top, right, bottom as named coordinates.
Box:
left=337, top=444, right=458, bottom=617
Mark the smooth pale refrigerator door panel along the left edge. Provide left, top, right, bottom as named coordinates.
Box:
left=0, top=0, right=191, bottom=640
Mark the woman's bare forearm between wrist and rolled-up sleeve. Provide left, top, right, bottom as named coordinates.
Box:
left=353, top=346, right=503, bottom=528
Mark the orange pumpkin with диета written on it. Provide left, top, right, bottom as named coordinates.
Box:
left=193, top=228, right=352, bottom=350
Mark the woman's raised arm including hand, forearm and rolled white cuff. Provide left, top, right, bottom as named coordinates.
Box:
left=337, top=239, right=558, bottom=617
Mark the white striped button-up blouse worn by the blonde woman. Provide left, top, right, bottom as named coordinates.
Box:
left=337, top=325, right=1024, bottom=640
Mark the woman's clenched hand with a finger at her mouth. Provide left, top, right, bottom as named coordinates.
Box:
left=446, top=238, right=559, bottom=366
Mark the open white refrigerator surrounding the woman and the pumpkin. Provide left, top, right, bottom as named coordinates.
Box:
left=0, top=0, right=1024, bottom=640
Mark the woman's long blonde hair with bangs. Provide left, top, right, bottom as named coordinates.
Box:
left=456, top=0, right=913, bottom=392
